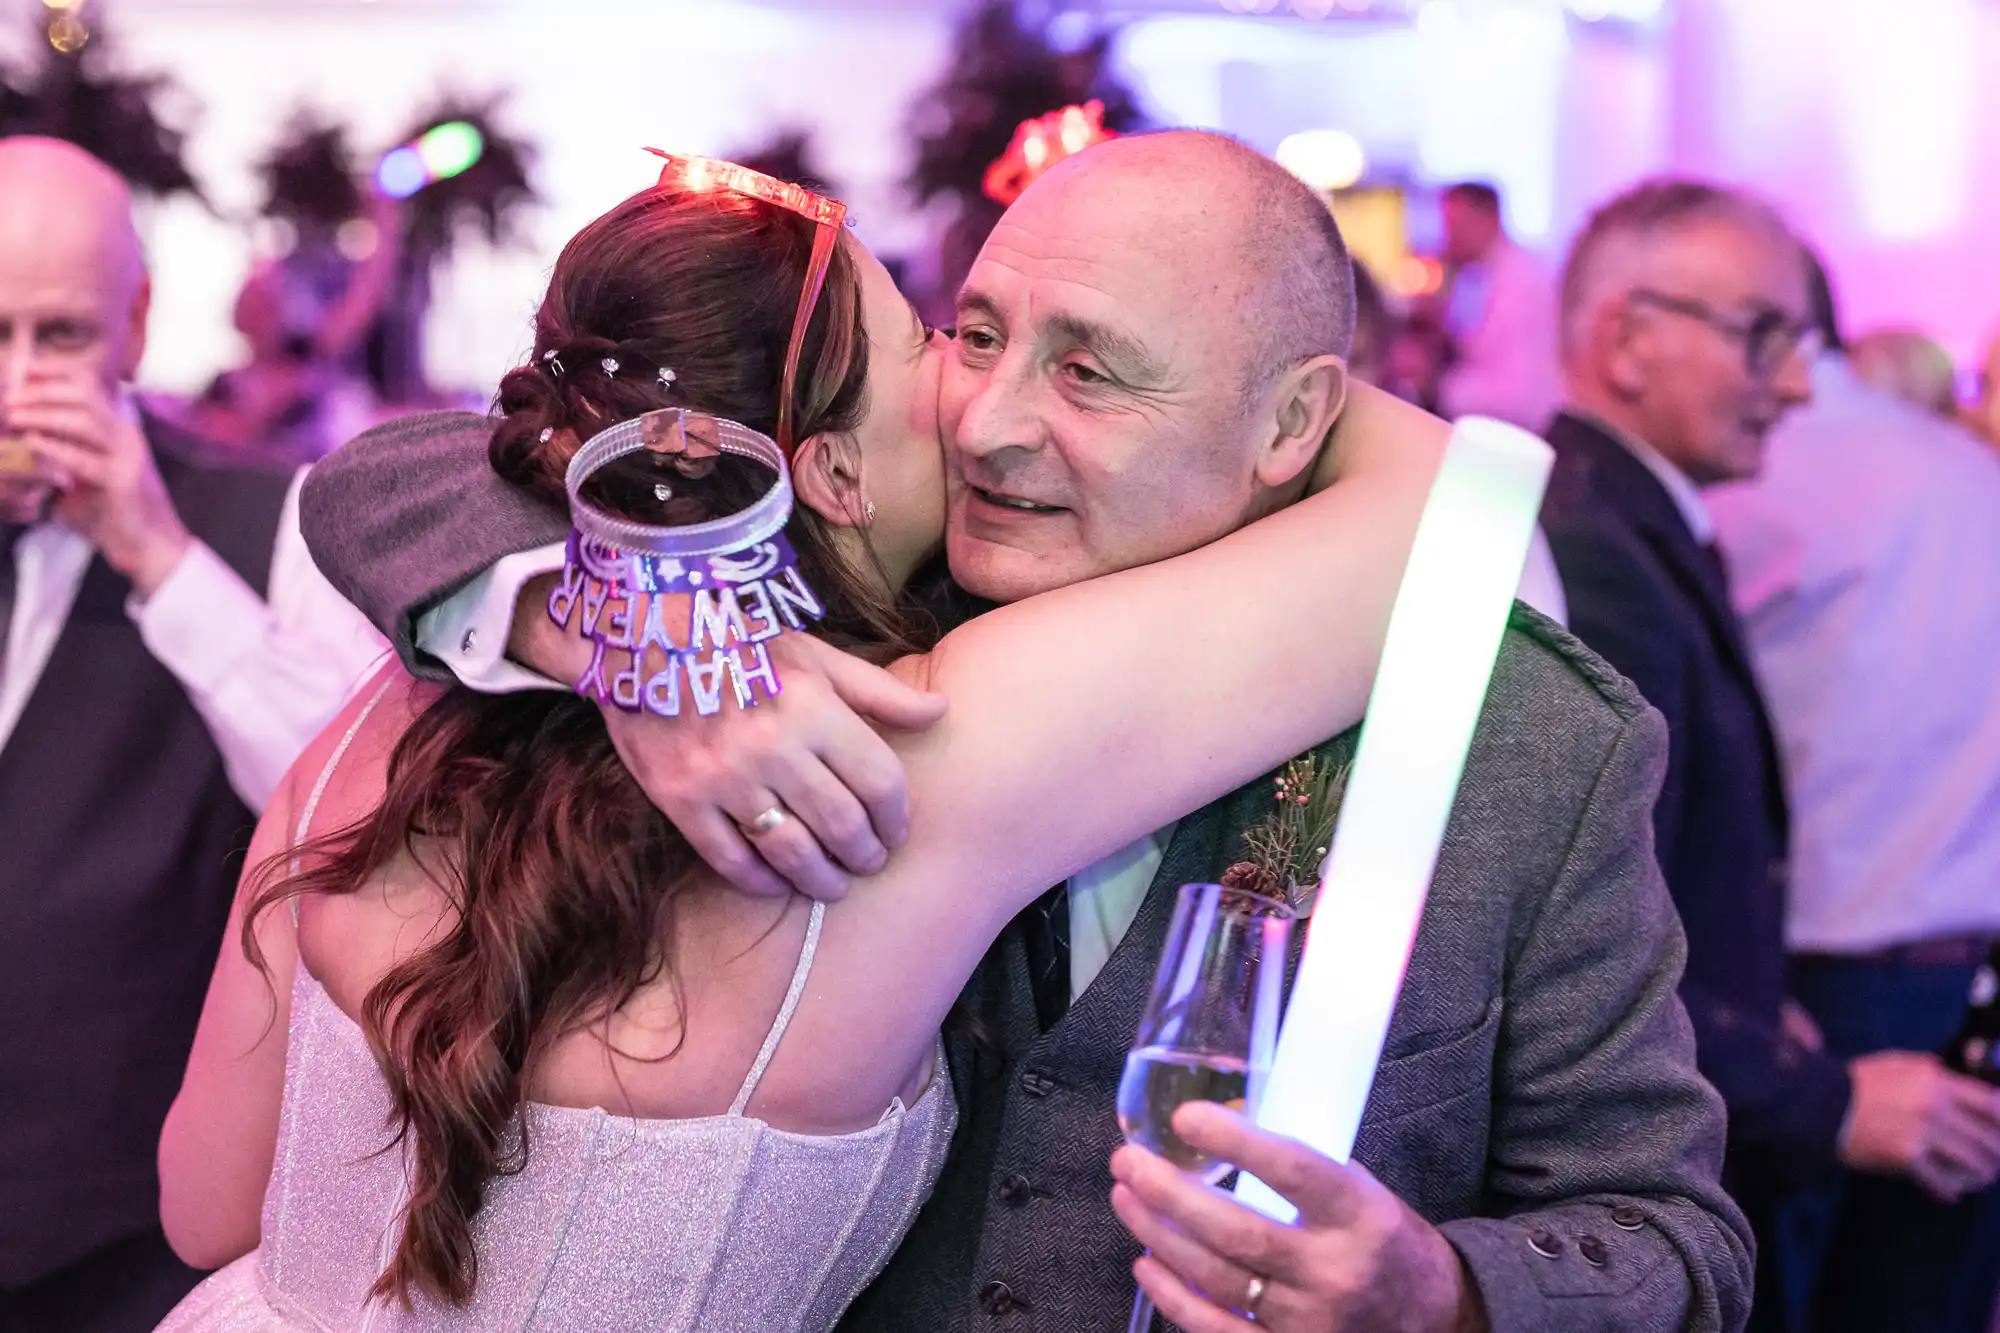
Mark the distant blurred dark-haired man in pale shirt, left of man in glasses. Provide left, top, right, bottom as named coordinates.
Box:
left=1438, top=184, right=1562, bottom=430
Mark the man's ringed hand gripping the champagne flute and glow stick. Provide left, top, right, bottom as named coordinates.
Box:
left=1112, top=1103, right=1488, bottom=1333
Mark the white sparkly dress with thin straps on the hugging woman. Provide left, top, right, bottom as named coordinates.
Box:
left=160, top=688, right=958, bottom=1333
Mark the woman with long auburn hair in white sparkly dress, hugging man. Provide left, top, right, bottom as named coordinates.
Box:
left=160, top=153, right=1442, bottom=1331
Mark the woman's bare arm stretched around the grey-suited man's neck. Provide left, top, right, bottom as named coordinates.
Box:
left=760, top=382, right=1448, bottom=1111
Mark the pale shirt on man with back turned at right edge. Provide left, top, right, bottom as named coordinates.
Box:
left=1708, top=356, right=2000, bottom=955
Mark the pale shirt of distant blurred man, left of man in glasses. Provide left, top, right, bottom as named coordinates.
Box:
left=1438, top=236, right=1562, bottom=434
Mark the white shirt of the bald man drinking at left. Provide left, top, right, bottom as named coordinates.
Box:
left=0, top=470, right=388, bottom=811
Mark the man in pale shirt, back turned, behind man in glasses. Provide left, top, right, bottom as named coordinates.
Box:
left=1710, top=264, right=2000, bottom=1333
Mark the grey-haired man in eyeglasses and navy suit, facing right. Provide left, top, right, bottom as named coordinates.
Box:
left=1544, top=180, right=2000, bottom=1329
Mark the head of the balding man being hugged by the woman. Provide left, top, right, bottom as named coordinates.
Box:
left=938, top=132, right=1354, bottom=600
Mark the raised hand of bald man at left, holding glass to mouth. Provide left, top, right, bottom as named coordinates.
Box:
left=0, top=346, right=192, bottom=596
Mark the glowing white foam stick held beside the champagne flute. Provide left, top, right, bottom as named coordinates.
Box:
left=1236, top=418, right=1554, bottom=1221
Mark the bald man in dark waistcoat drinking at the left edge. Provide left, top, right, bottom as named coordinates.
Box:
left=0, top=138, right=380, bottom=1333
